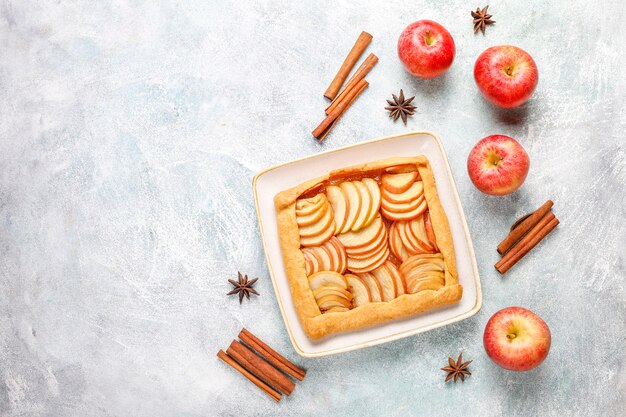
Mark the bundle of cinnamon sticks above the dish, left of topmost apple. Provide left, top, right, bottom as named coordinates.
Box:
left=312, top=32, right=378, bottom=142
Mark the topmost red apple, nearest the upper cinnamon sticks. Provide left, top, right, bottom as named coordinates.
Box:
left=398, top=20, right=456, bottom=78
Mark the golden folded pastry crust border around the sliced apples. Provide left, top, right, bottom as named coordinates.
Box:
left=274, top=156, right=463, bottom=339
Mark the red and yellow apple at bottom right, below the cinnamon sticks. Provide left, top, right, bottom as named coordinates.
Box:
left=483, top=307, right=551, bottom=371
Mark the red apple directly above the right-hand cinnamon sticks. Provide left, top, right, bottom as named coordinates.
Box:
left=467, top=135, right=530, bottom=195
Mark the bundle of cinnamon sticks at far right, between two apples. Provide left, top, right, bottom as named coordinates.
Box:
left=495, top=200, right=559, bottom=274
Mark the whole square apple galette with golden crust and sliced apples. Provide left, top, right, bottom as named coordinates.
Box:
left=274, top=156, right=463, bottom=339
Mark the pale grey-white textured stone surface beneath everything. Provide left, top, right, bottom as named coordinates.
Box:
left=0, top=0, right=626, bottom=417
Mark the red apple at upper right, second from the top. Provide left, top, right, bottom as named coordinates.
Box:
left=474, top=46, right=539, bottom=109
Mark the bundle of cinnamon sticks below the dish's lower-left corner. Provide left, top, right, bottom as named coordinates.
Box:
left=217, top=329, right=306, bottom=402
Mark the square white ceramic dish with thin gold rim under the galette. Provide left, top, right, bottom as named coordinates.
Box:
left=253, top=132, right=482, bottom=357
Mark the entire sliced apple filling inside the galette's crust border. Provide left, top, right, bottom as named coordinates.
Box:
left=296, top=167, right=445, bottom=313
